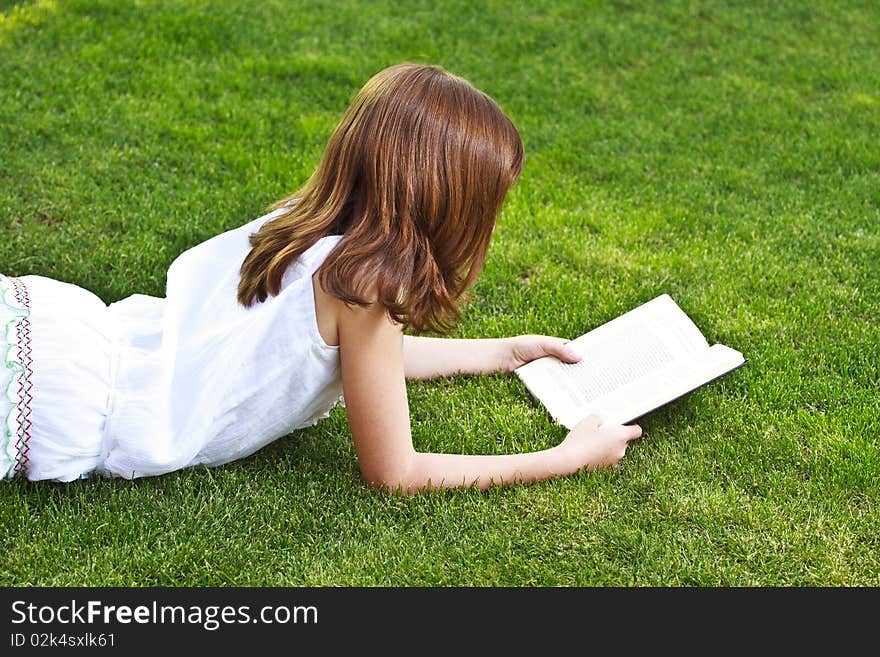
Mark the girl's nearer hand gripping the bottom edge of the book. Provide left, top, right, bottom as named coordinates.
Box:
left=559, top=415, right=642, bottom=470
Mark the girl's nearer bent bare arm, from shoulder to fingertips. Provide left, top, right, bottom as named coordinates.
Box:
left=336, top=304, right=641, bottom=493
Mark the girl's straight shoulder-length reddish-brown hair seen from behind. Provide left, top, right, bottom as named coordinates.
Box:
left=238, top=64, right=523, bottom=332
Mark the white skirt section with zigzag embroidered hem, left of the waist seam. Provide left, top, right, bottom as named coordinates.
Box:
left=0, top=274, right=115, bottom=481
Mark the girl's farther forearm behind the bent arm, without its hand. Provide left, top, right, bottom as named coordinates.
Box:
left=403, top=335, right=510, bottom=379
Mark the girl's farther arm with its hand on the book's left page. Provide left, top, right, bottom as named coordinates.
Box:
left=403, top=335, right=580, bottom=379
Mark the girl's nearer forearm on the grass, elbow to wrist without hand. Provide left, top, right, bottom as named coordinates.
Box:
left=385, top=445, right=579, bottom=493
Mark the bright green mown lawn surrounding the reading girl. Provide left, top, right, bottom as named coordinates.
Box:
left=0, top=0, right=880, bottom=586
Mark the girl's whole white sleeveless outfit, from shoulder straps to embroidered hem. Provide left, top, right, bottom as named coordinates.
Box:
left=0, top=211, right=343, bottom=481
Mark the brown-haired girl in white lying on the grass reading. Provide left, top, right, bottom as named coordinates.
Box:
left=0, top=64, right=641, bottom=493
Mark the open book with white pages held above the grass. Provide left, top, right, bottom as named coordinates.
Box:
left=514, top=294, right=747, bottom=429
